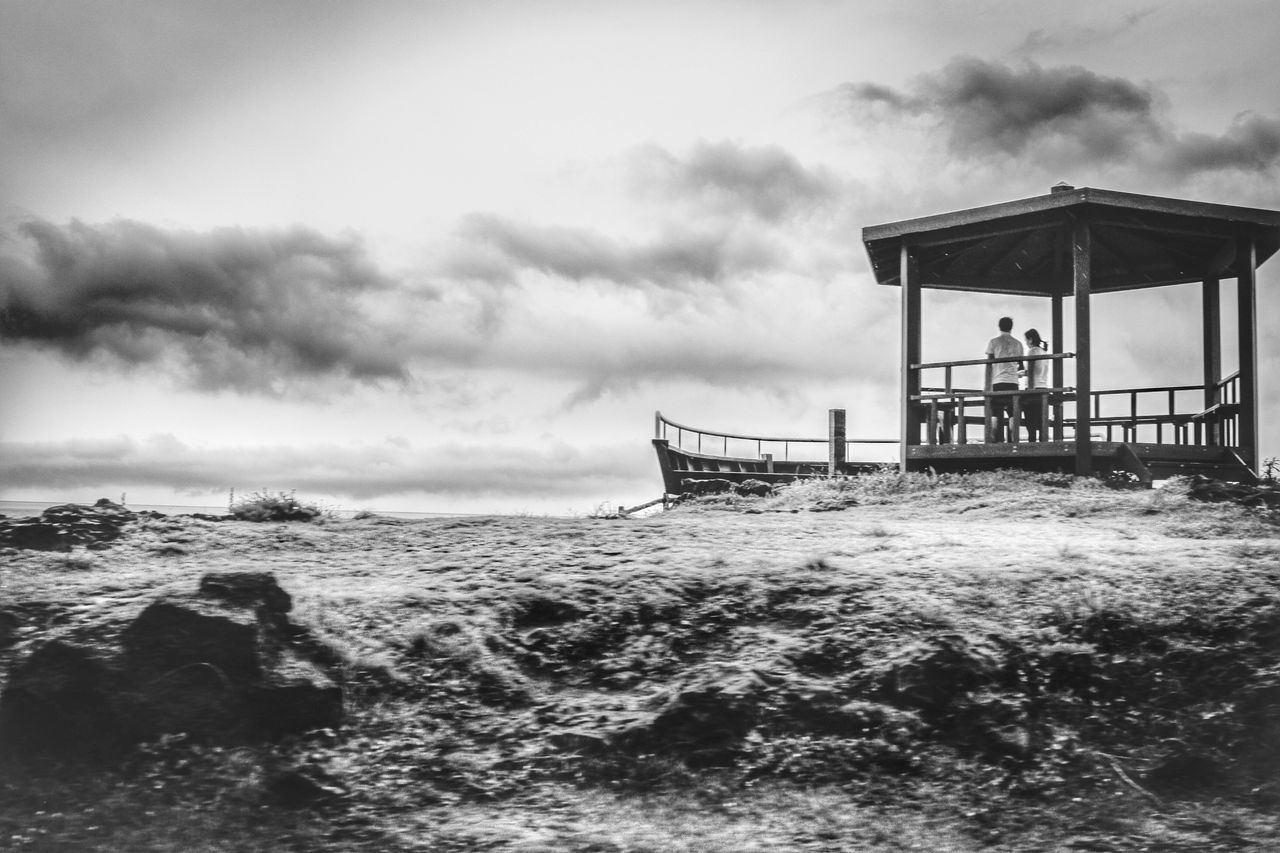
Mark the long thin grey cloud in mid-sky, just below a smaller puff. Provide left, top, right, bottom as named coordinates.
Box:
left=447, top=214, right=781, bottom=289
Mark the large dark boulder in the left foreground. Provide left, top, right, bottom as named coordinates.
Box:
left=0, top=573, right=343, bottom=754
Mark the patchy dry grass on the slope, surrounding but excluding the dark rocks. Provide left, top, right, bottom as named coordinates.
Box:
left=0, top=473, right=1280, bottom=852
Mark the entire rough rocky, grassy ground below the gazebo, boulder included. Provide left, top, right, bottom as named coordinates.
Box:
left=0, top=474, right=1280, bottom=853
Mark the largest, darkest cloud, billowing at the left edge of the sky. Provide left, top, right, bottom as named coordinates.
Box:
left=0, top=220, right=407, bottom=392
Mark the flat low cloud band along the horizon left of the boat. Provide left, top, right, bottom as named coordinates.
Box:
left=0, top=435, right=658, bottom=501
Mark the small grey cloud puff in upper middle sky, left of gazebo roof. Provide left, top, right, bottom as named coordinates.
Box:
left=631, top=142, right=838, bottom=223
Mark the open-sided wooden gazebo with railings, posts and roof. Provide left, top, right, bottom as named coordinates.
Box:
left=863, top=184, right=1280, bottom=482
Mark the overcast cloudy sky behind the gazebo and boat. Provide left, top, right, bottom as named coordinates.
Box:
left=0, top=0, right=1280, bottom=515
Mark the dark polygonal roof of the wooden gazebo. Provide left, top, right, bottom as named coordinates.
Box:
left=863, top=187, right=1280, bottom=296
